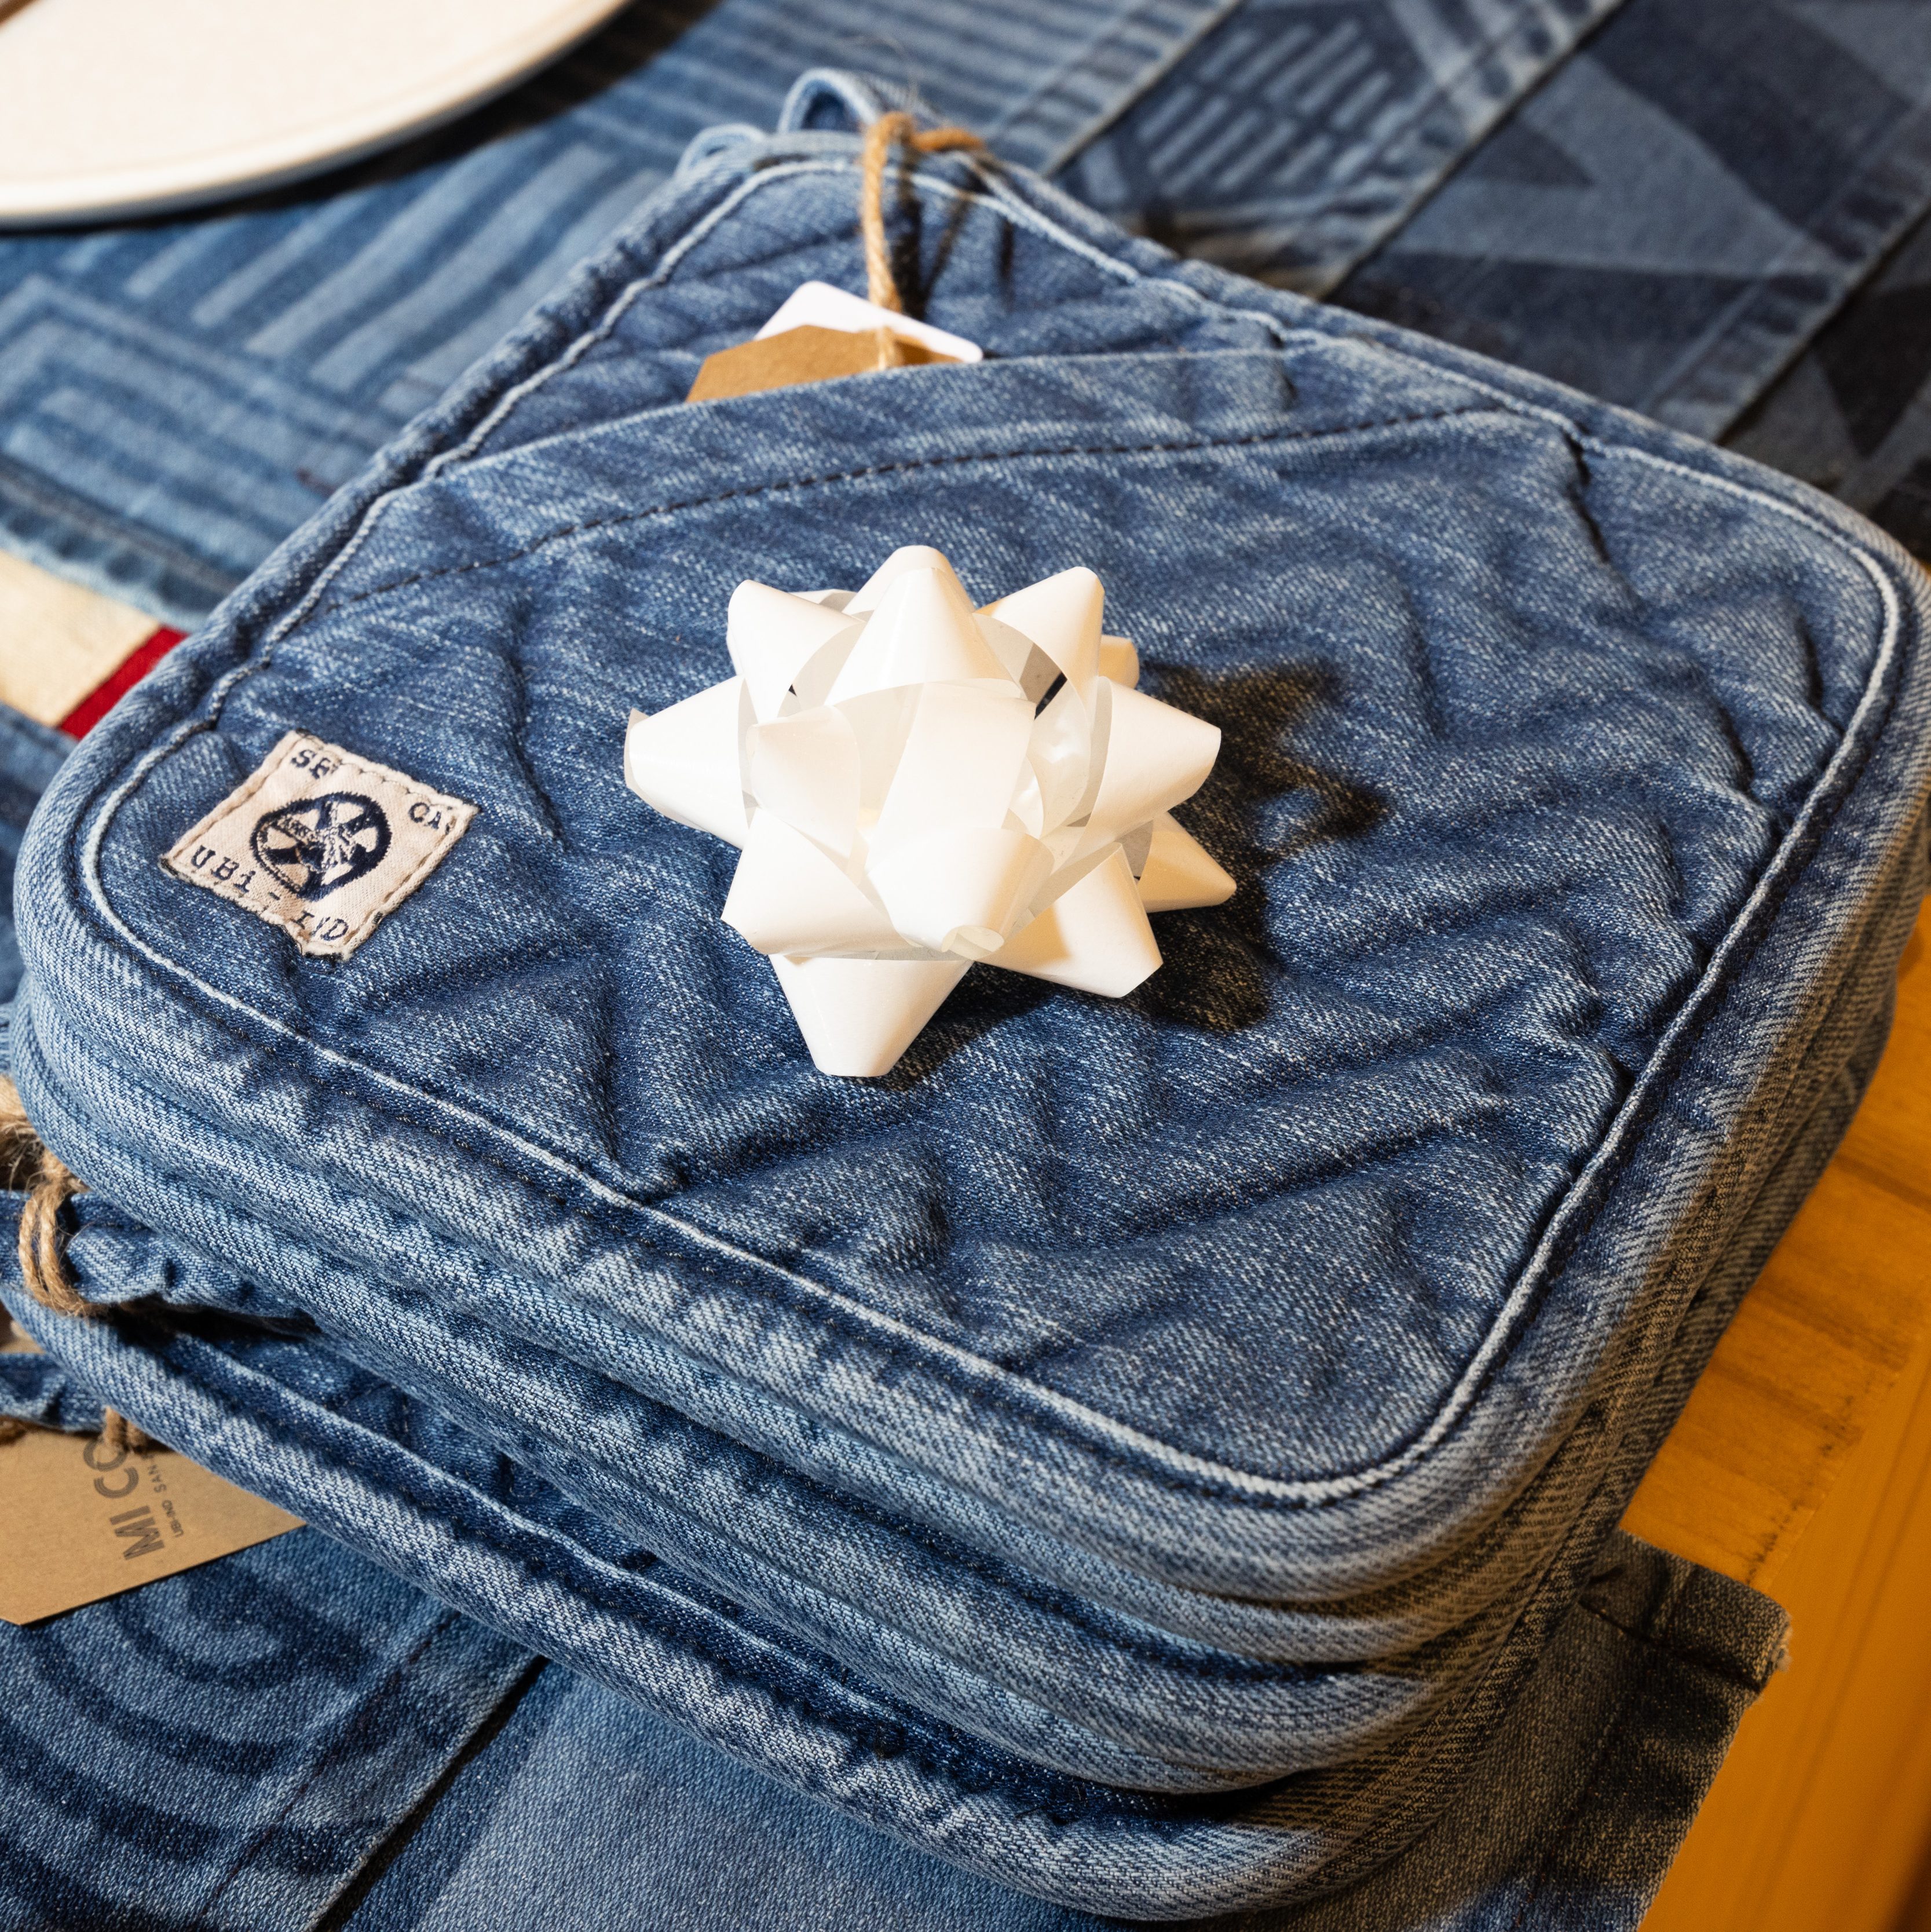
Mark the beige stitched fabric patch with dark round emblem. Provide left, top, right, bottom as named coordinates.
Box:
left=160, top=731, right=477, bottom=958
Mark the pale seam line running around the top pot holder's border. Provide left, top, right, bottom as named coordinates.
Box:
left=53, top=140, right=1902, bottom=1507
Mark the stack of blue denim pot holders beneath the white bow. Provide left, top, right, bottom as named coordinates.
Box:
left=6, top=83, right=1931, bottom=1919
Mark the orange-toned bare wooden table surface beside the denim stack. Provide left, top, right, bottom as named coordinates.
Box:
left=1624, top=914, right=1931, bottom=1932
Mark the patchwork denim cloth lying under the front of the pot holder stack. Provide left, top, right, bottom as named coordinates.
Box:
left=0, top=728, right=1791, bottom=1932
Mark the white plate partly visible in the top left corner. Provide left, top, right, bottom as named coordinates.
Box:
left=0, top=0, right=624, bottom=226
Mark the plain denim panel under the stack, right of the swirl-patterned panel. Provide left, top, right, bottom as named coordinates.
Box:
left=324, top=1538, right=1780, bottom=1932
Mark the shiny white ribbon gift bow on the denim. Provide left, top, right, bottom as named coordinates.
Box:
left=624, top=545, right=1234, bottom=1078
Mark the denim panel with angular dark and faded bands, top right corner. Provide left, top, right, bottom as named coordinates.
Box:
left=1336, top=0, right=1931, bottom=440
